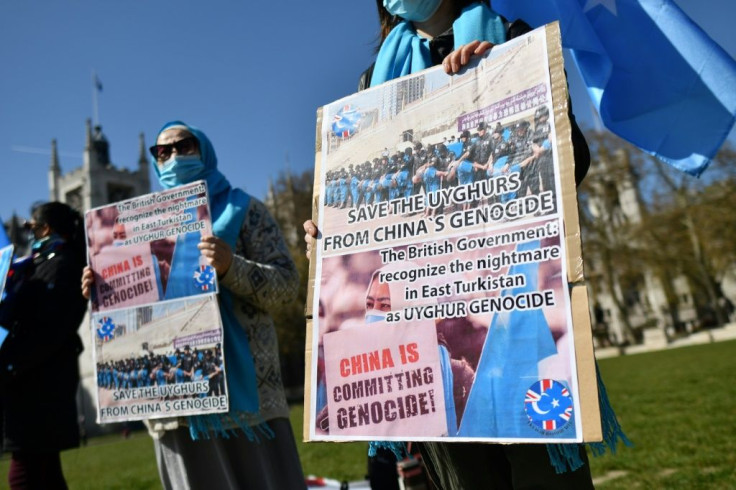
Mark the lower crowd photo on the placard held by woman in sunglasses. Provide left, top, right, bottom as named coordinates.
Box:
left=92, top=295, right=227, bottom=418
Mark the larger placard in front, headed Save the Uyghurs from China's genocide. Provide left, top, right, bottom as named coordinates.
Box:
left=304, top=24, right=601, bottom=443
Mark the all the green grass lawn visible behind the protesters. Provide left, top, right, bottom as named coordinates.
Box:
left=0, top=341, right=736, bottom=490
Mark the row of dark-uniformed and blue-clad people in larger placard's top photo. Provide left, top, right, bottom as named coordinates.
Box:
left=323, top=105, right=556, bottom=215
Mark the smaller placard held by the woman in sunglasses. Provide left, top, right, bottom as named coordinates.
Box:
left=85, top=181, right=228, bottom=423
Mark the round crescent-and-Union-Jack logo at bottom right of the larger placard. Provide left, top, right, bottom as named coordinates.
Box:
left=524, top=379, right=573, bottom=431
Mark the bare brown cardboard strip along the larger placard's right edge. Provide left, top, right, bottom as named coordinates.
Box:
left=545, top=22, right=603, bottom=442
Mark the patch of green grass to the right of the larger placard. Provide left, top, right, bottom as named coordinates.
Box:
left=591, top=341, right=736, bottom=489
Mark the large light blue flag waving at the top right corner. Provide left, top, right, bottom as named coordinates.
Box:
left=493, top=0, right=736, bottom=175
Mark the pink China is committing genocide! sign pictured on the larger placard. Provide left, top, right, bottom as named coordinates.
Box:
left=323, top=322, right=447, bottom=438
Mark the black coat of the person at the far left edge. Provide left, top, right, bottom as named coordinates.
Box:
left=0, top=240, right=87, bottom=452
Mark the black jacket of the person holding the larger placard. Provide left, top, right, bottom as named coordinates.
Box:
left=358, top=20, right=590, bottom=185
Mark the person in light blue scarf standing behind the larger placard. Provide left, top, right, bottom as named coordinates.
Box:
left=304, top=0, right=604, bottom=489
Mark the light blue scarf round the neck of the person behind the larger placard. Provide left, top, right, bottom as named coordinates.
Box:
left=371, top=3, right=506, bottom=87
